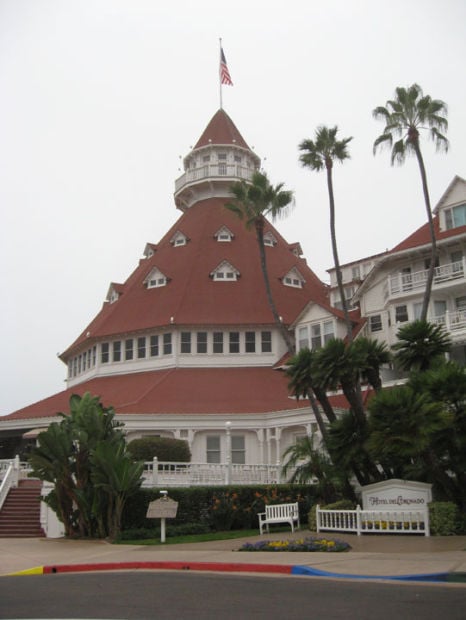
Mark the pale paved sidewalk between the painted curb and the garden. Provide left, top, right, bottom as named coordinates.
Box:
left=0, top=530, right=466, bottom=586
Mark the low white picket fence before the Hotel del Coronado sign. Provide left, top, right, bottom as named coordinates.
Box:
left=316, top=506, right=430, bottom=536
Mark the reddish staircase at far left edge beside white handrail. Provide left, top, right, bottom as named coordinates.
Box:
left=0, top=480, right=45, bottom=538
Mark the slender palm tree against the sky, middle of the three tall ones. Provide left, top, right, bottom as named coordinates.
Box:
left=299, top=126, right=353, bottom=342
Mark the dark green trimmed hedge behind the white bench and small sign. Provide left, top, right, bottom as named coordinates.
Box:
left=122, top=484, right=316, bottom=531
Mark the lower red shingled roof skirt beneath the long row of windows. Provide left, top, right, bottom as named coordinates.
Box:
left=2, top=368, right=308, bottom=421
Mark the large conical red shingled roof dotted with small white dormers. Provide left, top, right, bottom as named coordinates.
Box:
left=62, top=198, right=328, bottom=359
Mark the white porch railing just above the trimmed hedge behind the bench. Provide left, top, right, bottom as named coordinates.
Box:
left=143, top=458, right=281, bottom=487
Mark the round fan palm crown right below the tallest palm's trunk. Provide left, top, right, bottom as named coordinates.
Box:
left=392, top=319, right=451, bottom=371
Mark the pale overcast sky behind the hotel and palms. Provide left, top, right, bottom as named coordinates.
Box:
left=0, top=0, right=466, bottom=414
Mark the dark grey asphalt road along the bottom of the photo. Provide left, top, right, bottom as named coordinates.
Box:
left=0, top=571, right=466, bottom=620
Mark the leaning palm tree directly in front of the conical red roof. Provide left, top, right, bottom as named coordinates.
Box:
left=225, top=171, right=294, bottom=354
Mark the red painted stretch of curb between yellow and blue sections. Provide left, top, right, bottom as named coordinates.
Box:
left=43, top=562, right=293, bottom=575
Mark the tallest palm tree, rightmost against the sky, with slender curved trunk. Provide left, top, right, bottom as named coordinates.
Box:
left=372, top=84, right=448, bottom=320
